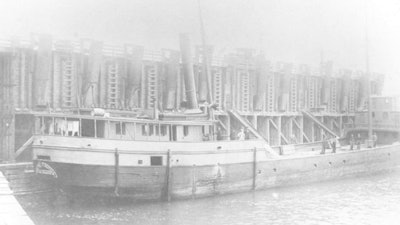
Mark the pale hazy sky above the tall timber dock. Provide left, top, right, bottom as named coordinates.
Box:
left=0, top=0, right=400, bottom=95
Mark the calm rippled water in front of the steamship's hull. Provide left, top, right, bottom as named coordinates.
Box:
left=20, top=172, right=400, bottom=225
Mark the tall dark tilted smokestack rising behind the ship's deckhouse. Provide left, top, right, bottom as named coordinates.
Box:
left=180, top=34, right=199, bottom=109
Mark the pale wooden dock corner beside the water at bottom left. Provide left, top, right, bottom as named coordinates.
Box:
left=0, top=172, right=34, bottom=225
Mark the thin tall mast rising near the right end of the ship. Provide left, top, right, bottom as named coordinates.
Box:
left=365, top=0, right=372, bottom=148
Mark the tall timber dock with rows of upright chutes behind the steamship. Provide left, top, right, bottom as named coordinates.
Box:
left=0, top=35, right=383, bottom=162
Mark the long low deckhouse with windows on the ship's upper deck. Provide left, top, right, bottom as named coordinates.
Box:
left=35, top=113, right=222, bottom=142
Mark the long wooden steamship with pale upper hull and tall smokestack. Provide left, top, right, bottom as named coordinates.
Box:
left=32, top=36, right=400, bottom=200
